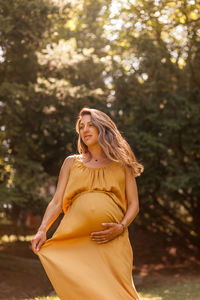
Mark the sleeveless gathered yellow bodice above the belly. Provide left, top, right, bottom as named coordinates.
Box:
left=62, top=155, right=127, bottom=213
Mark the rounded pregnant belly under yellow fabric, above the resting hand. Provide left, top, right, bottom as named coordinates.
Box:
left=55, top=192, right=123, bottom=237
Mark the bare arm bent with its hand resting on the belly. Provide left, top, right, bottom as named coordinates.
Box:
left=90, top=167, right=139, bottom=244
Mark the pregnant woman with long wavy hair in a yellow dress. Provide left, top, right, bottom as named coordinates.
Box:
left=31, top=108, right=143, bottom=300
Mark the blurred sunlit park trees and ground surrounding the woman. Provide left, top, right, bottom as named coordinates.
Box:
left=0, top=0, right=200, bottom=300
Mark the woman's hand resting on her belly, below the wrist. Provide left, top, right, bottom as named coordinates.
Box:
left=90, top=223, right=123, bottom=244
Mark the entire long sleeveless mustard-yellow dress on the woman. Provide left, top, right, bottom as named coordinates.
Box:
left=38, top=155, right=139, bottom=300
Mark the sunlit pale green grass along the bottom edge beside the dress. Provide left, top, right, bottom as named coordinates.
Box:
left=27, top=279, right=200, bottom=300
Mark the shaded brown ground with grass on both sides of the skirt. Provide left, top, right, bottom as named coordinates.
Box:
left=0, top=221, right=200, bottom=300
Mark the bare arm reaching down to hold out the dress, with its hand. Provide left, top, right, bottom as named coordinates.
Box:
left=31, top=156, right=73, bottom=254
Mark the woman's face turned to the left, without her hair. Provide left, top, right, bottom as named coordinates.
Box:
left=79, top=115, right=99, bottom=147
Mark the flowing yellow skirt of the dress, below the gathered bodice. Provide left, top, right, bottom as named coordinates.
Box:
left=38, top=191, right=139, bottom=300
